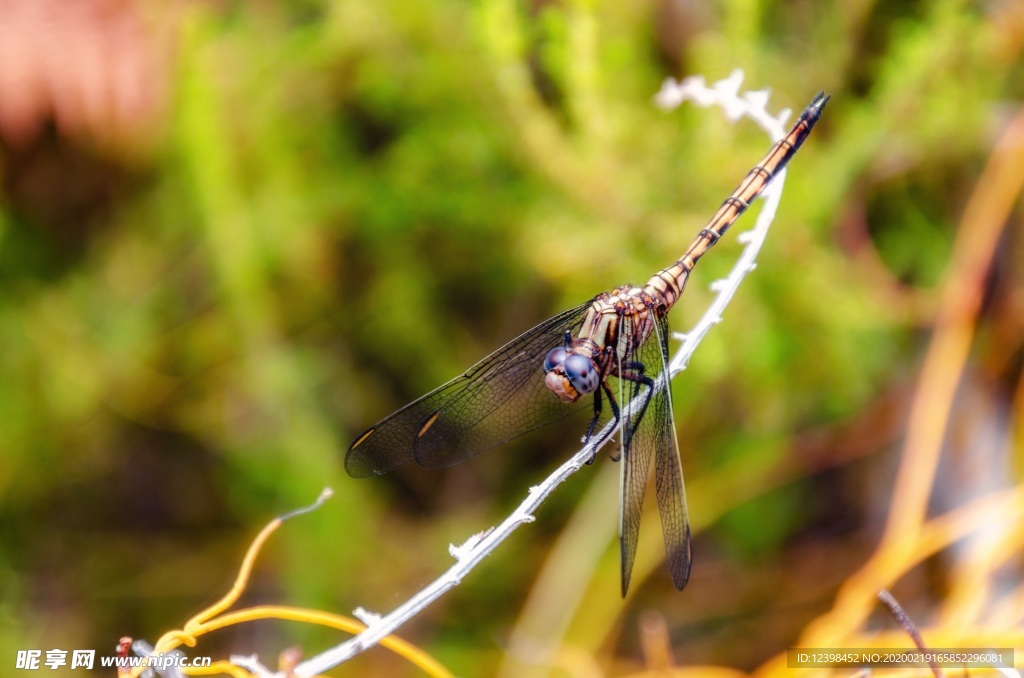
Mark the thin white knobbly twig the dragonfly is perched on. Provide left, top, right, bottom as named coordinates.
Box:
left=294, top=71, right=791, bottom=676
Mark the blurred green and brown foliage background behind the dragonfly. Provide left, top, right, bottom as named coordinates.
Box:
left=0, top=0, right=1024, bottom=676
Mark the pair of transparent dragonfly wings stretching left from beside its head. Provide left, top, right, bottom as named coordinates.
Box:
left=345, top=301, right=591, bottom=477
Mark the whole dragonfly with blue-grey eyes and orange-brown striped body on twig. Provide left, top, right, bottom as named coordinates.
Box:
left=345, top=92, right=829, bottom=597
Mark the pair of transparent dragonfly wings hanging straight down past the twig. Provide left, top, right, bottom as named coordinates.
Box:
left=618, top=309, right=692, bottom=596
